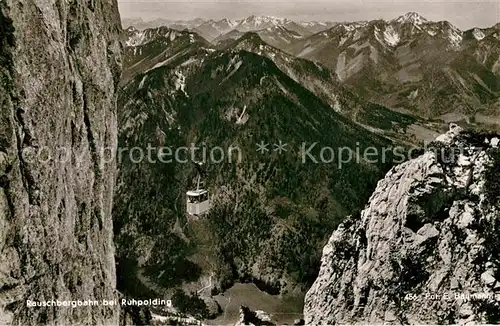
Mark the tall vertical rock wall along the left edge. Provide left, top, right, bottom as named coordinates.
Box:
left=0, top=0, right=121, bottom=325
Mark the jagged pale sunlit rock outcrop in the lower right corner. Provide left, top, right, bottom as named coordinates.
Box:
left=304, top=127, right=500, bottom=324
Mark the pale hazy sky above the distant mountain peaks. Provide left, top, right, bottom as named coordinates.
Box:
left=118, top=0, right=500, bottom=30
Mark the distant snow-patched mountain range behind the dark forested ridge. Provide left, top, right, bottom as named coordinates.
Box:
left=124, top=12, right=500, bottom=128
